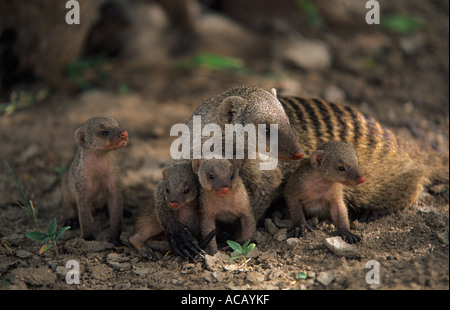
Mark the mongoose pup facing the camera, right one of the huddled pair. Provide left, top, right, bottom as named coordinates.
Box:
left=192, top=159, right=256, bottom=255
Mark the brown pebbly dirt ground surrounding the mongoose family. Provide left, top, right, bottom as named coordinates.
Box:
left=0, top=0, right=449, bottom=290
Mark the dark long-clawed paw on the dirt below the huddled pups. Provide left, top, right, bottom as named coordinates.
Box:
left=167, top=227, right=204, bottom=261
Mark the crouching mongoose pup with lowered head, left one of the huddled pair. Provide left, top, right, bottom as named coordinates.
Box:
left=130, top=160, right=200, bottom=260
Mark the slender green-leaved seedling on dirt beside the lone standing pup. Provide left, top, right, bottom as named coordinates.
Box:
left=5, top=160, right=70, bottom=254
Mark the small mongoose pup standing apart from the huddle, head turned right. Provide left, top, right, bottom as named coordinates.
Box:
left=62, top=116, right=128, bottom=245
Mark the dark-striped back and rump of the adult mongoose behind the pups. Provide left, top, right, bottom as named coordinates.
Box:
left=278, top=96, right=449, bottom=221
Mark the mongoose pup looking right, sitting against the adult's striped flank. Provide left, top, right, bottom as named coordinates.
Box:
left=284, top=141, right=366, bottom=243
